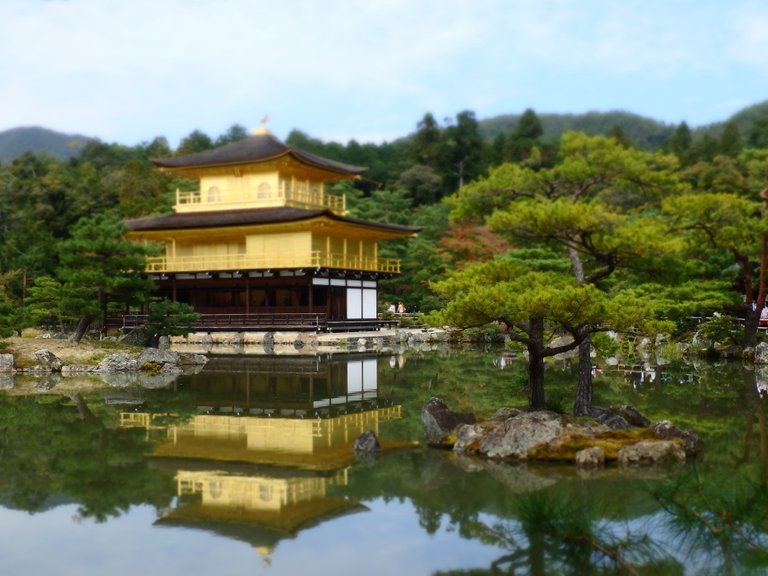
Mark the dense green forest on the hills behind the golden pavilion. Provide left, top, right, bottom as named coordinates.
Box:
left=0, top=103, right=768, bottom=338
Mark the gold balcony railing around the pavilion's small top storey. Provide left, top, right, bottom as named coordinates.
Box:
left=176, top=180, right=347, bottom=214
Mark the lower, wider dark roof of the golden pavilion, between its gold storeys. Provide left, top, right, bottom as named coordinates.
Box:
left=125, top=208, right=421, bottom=234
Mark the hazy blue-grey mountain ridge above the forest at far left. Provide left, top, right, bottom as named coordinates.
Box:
left=0, top=126, right=95, bottom=163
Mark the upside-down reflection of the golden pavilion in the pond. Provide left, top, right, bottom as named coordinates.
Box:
left=121, top=356, right=401, bottom=557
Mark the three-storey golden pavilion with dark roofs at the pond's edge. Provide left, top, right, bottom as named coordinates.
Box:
left=126, top=128, right=419, bottom=330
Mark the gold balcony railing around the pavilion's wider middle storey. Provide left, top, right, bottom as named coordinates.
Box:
left=146, top=250, right=400, bottom=274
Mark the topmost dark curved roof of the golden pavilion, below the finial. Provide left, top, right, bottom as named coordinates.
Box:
left=152, top=132, right=367, bottom=175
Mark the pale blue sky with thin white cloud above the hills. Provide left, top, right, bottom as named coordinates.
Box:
left=0, top=0, right=768, bottom=146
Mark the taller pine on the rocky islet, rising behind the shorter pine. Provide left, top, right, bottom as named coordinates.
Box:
left=451, top=133, right=678, bottom=414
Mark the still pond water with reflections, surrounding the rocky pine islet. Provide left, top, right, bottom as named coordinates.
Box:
left=0, top=351, right=768, bottom=576
